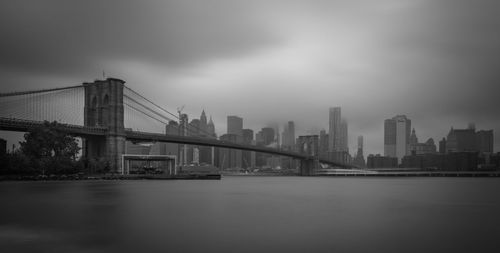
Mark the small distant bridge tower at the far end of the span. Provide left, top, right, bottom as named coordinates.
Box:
left=297, top=135, right=319, bottom=176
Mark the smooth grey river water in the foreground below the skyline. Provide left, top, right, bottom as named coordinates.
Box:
left=0, top=177, right=500, bottom=252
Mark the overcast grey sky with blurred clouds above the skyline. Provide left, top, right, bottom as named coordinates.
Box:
left=0, top=0, right=500, bottom=155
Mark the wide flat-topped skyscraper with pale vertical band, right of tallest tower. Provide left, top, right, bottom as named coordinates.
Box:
left=384, top=115, right=411, bottom=161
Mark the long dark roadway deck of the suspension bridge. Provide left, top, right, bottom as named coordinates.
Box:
left=0, top=117, right=354, bottom=168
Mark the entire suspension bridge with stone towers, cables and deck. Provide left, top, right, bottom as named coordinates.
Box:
left=0, top=78, right=354, bottom=175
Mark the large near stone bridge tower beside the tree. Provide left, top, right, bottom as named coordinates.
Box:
left=83, top=78, right=125, bottom=173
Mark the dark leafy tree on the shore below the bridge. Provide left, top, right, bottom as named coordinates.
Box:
left=20, top=121, right=80, bottom=174
